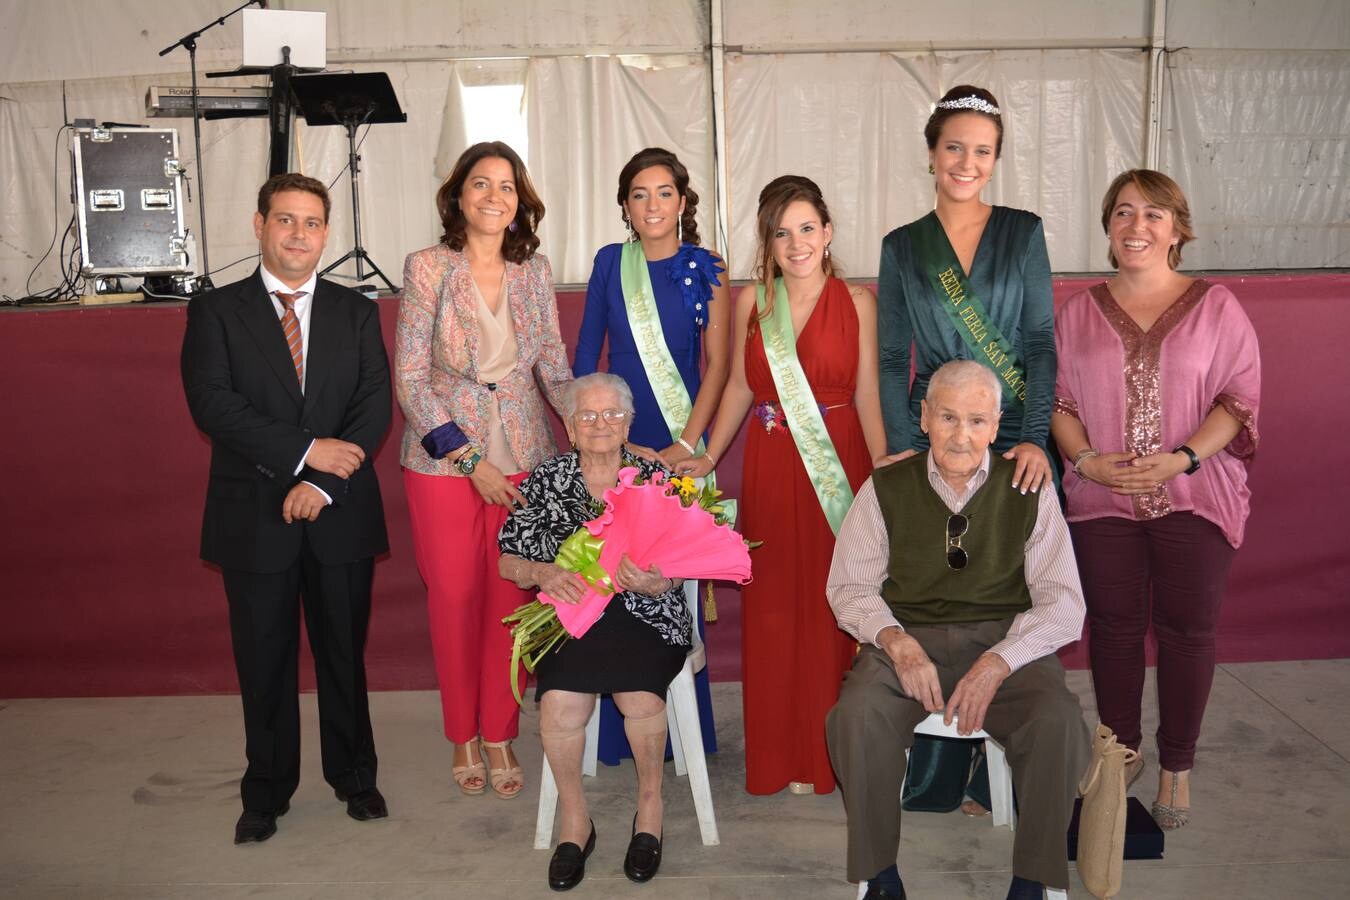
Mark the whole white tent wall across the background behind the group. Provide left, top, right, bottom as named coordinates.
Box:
left=0, top=0, right=1350, bottom=296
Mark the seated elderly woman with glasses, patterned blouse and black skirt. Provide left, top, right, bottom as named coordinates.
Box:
left=498, top=372, right=693, bottom=891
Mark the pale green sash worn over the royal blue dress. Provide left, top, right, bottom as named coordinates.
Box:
left=618, top=240, right=736, bottom=522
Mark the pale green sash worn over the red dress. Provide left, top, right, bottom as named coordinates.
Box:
left=755, top=278, right=853, bottom=534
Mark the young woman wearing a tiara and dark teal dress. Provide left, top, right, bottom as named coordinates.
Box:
left=876, top=85, right=1056, bottom=815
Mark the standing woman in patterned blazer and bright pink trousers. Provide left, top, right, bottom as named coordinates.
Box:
left=394, top=142, right=572, bottom=799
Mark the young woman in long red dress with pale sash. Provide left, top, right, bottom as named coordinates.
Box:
left=678, top=175, right=886, bottom=793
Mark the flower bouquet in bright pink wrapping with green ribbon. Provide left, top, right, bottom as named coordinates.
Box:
left=502, top=467, right=751, bottom=702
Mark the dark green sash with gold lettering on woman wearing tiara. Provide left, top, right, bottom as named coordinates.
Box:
left=909, top=212, right=1026, bottom=406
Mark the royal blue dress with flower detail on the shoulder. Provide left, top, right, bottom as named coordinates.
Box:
left=572, top=244, right=717, bottom=765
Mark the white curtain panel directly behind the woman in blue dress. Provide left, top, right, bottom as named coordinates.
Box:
left=525, top=57, right=717, bottom=283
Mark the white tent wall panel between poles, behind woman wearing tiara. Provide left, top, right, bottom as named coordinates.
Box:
left=726, top=50, right=1146, bottom=278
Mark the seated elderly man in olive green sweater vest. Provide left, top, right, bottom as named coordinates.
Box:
left=826, top=360, right=1088, bottom=900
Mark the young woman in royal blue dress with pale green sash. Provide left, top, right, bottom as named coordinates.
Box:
left=572, top=147, right=730, bottom=765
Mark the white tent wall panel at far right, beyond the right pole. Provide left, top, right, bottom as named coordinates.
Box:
left=1162, top=50, right=1350, bottom=269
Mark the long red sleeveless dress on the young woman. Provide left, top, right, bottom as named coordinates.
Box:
left=741, top=278, right=872, bottom=793
